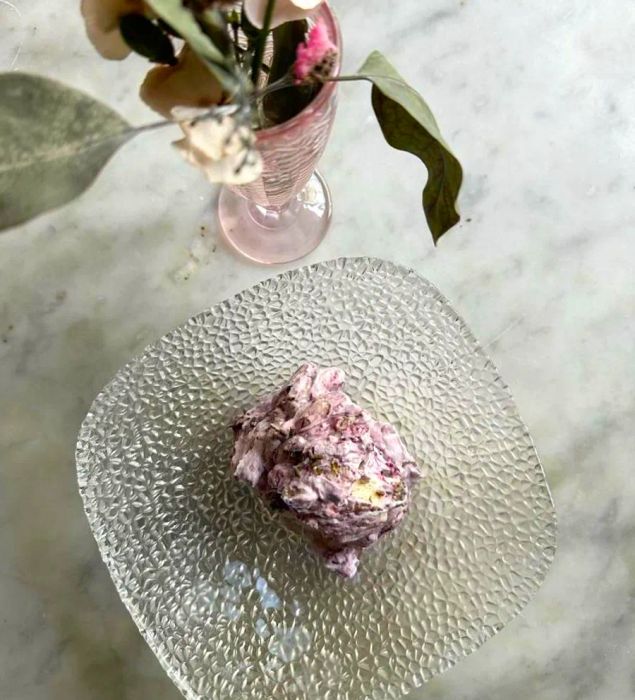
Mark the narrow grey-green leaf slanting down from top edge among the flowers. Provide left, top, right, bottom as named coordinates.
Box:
left=146, top=0, right=236, bottom=91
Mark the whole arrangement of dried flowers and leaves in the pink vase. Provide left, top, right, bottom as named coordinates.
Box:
left=0, top=0, right=462, bottom=242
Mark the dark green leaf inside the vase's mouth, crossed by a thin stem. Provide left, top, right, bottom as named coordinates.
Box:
left=262, top=20, right=320, bottom=124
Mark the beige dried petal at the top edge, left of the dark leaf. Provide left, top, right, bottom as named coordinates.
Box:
left=81, top=0, right=145, bottom=61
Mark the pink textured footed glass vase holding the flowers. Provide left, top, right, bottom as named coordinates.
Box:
left=218, top=3, right=341, bottom=264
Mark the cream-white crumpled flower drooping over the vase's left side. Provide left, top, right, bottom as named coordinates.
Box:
left=172, top=107, right=262, bottom=185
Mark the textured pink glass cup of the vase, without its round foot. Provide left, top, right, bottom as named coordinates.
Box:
left=229, top=4, right=339, bottom=207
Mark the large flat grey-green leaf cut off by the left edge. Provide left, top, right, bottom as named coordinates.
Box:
left=0, top=73, right=134, bottom=230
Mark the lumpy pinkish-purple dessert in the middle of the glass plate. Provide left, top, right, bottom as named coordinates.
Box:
left=231, top=363, right=420, bottom=577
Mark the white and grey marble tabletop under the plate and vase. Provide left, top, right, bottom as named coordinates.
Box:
left=0, top=0, right=635, bottom=700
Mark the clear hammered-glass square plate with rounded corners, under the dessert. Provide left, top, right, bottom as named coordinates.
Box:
left=77, top=258, right=556, bottom=700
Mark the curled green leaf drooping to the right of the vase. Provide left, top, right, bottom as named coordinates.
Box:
left=357, top=51, right=463, bottom=244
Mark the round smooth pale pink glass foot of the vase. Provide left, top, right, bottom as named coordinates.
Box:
left=218, top=172, right=332, bottom=265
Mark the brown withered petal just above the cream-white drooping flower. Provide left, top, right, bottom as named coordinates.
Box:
left=139, top=44, right=223, bottom=118
